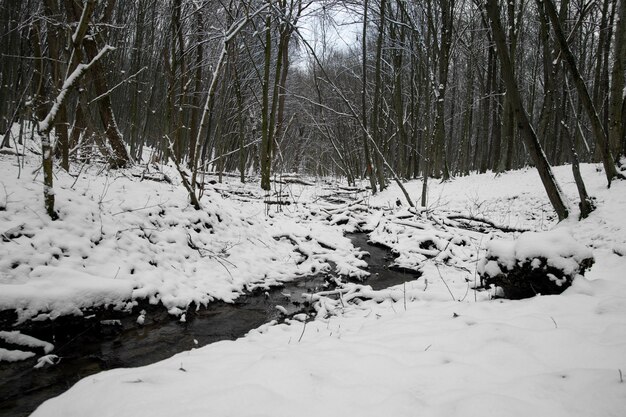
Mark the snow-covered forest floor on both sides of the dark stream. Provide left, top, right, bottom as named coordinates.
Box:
left=0, top=142, right=626, bottom=417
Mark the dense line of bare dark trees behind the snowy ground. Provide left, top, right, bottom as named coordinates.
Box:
left=0, top=0, right=626, bottom=218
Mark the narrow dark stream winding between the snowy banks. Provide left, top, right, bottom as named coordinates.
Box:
left=0, top=233, right=417, bottom=417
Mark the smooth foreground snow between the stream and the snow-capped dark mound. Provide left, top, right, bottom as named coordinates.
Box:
left=29, top=260, right=626, bottom=417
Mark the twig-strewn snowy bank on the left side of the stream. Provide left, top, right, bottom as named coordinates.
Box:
left=0, top=146, right=367, bottom=322
